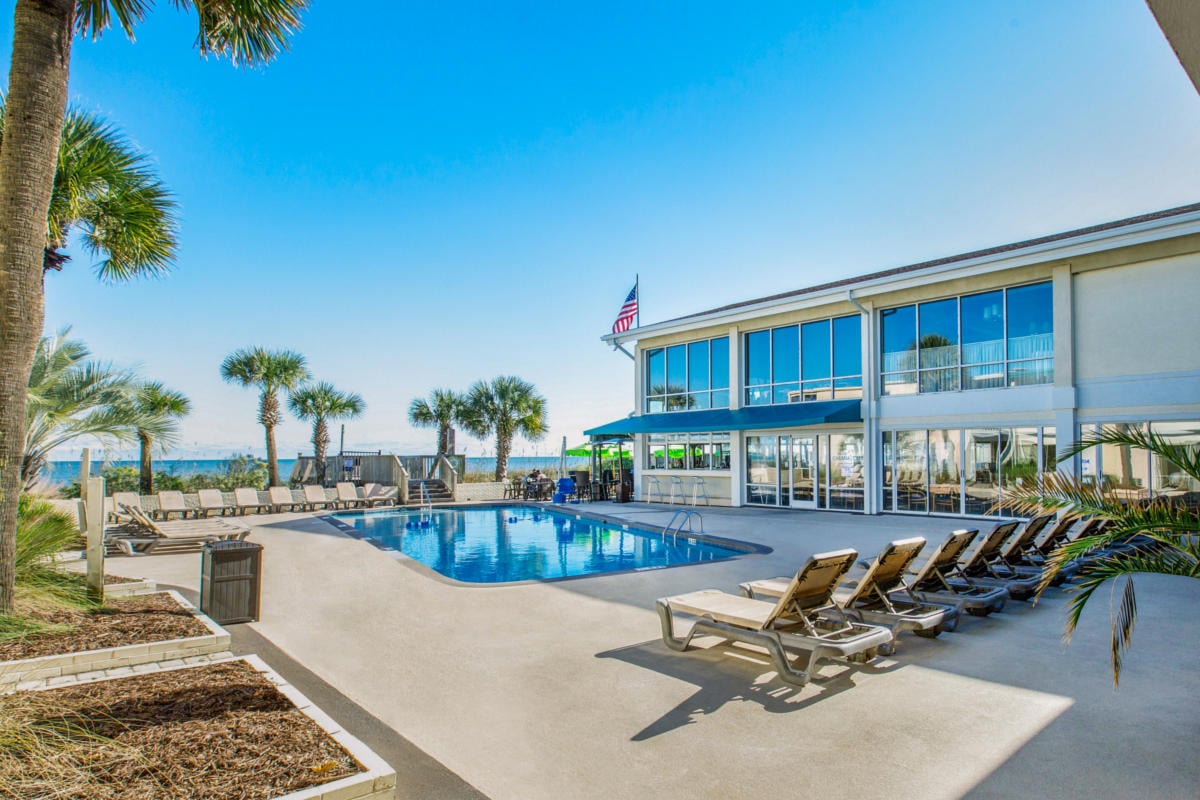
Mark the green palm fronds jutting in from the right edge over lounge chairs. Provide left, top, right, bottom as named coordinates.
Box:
left=1013, top=426, right=1200, bottom=685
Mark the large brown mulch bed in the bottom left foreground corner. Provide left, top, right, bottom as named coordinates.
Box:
left=0, top=661, right=360, bottom=800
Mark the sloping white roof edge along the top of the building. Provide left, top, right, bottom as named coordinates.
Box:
left=601, top=203, right=1200, bottom=342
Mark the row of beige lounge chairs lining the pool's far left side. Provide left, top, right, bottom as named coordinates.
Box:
left=113, top=482, right=398, bottom=521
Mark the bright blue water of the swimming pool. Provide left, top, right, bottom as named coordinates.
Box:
left=335, top=506, right=742, bottom=583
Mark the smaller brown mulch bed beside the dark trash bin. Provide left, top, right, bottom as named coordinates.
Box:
left=0, top=594, right=210, bottom=661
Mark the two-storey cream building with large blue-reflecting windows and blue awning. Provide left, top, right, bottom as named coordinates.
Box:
left=587, top=204, right=1200, bottom=516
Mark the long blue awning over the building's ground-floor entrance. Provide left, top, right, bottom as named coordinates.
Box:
left=583, top=399, right=863, bottom=439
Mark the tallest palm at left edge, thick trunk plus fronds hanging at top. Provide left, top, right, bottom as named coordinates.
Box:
left=0, top=0, right=308, bottom=614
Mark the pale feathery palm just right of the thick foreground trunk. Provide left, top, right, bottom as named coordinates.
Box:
left=20, top=330, right=172, bottom=488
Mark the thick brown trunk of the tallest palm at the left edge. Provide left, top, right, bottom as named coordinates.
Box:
left=0, top=0, right=76, bottom=614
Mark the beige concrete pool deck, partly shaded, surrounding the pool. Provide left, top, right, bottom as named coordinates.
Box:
left=96, top=503, right=1200, bottom=800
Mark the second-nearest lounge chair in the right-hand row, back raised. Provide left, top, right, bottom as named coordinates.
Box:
left=738, top=536, right=959, bottom=638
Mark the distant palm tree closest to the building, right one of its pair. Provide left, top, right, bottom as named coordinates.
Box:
left=462, top=375, right=547, bottom=481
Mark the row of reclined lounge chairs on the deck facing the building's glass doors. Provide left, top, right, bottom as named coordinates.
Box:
left=658, top=515, right=1104, bottom=686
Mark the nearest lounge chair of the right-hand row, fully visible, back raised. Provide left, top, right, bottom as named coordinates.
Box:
left=658, top=549, right=892, bottom=686
